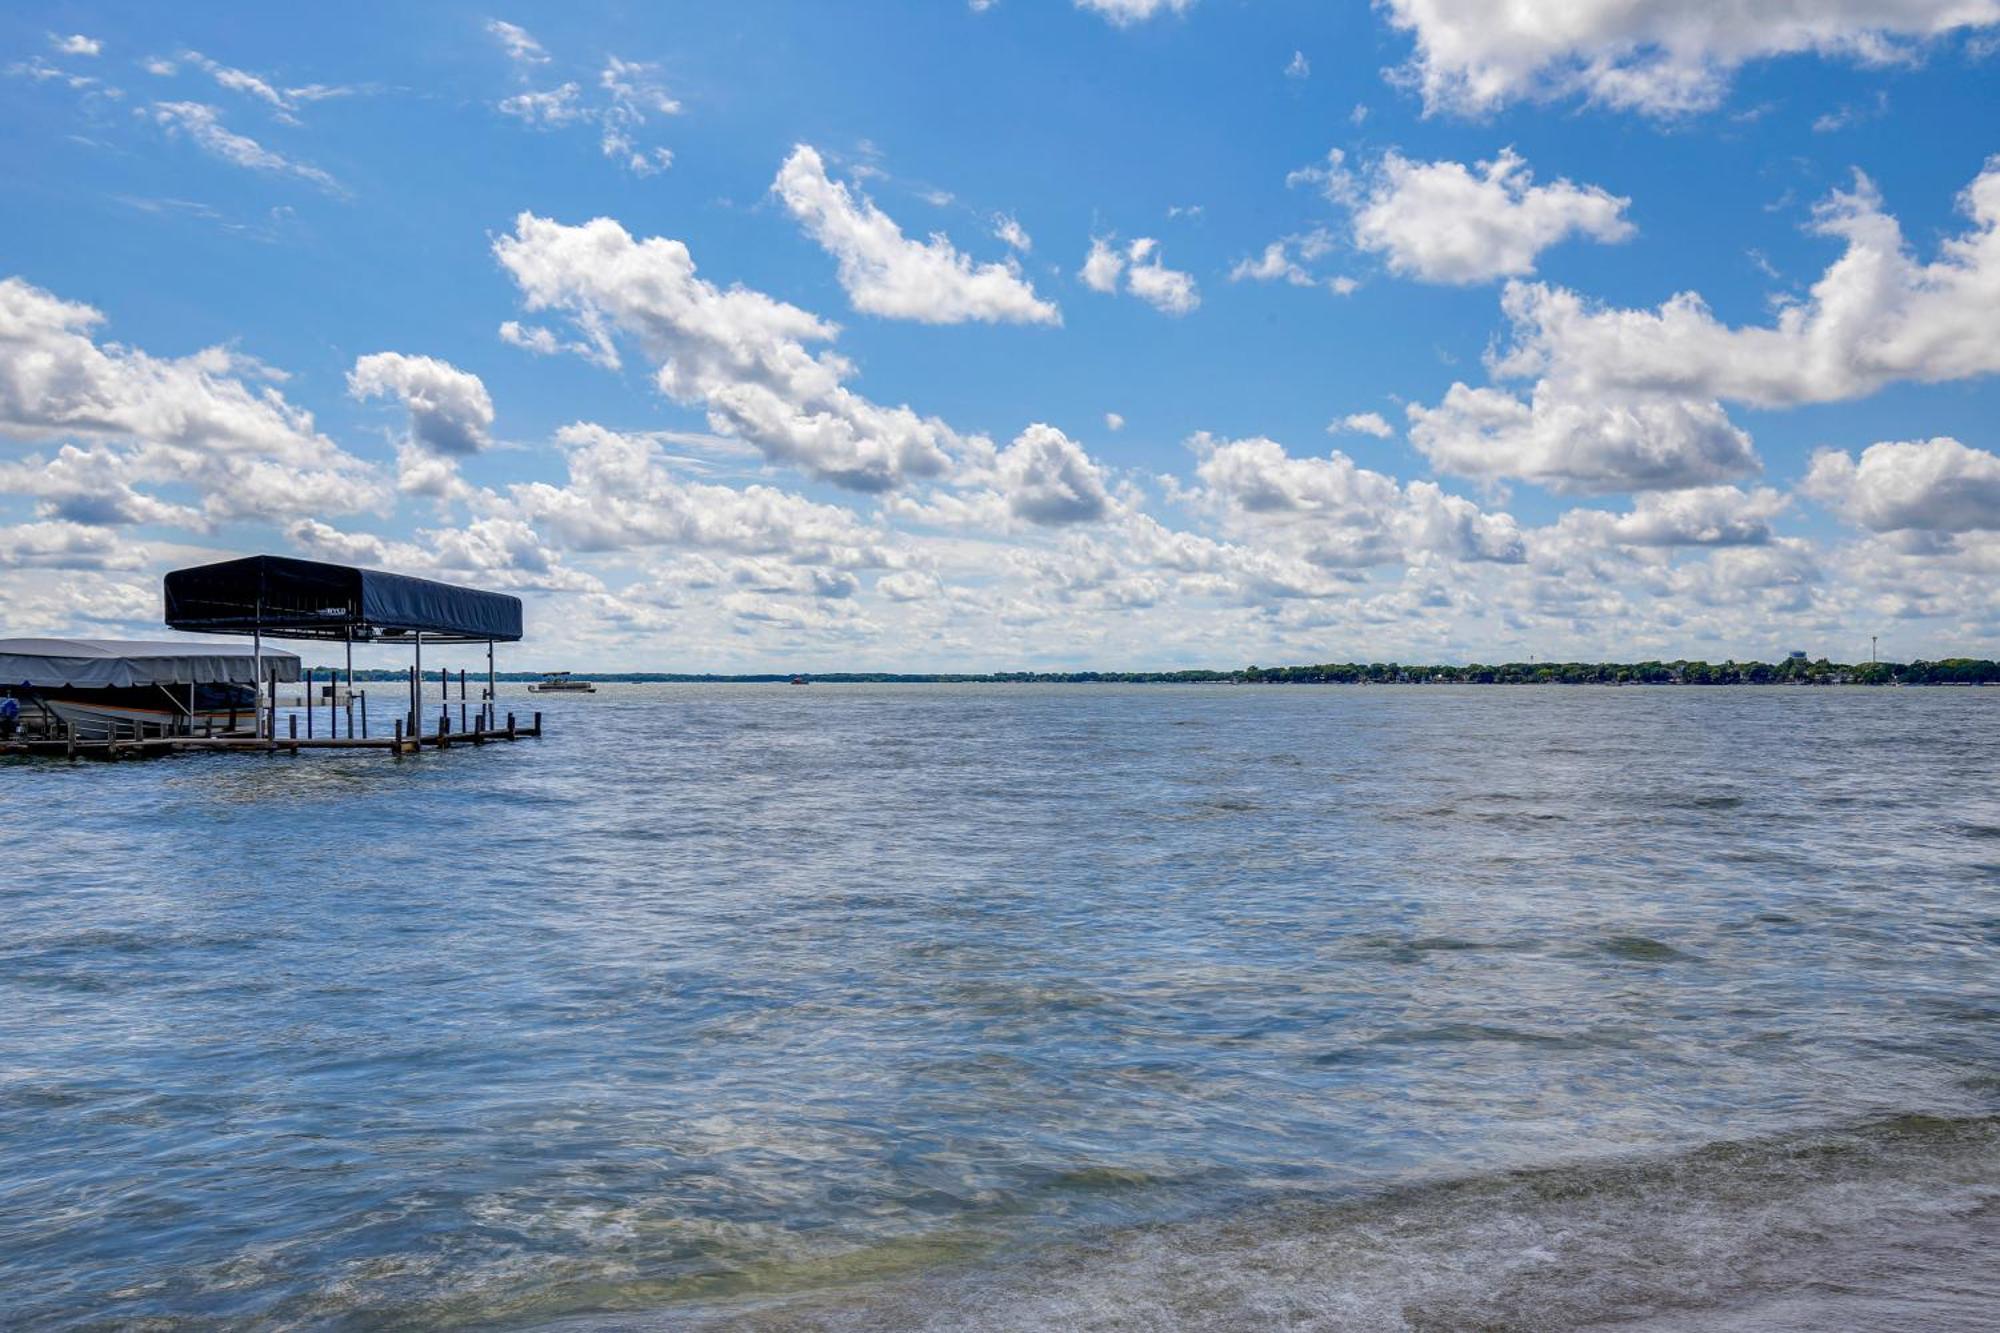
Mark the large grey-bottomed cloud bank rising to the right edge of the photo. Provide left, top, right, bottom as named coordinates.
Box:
left=1410, top=158, right=2000, bottom=490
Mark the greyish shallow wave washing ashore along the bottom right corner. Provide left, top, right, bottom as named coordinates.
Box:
left=600, top=1115, right=2000, bottom=1333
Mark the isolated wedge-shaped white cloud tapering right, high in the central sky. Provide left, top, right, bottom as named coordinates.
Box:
left=772, top=144, right=1062, bottom=324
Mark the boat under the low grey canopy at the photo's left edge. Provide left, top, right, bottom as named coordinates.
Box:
left=0, top=638, right=300, bottom=741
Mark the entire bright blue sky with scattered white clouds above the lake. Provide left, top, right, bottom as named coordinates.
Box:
left=0, top=0, right=2000, bottom=671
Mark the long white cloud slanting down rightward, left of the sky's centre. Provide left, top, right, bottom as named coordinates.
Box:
left=494, top=212, right=956, bottom=490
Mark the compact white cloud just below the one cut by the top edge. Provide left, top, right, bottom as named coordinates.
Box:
left=1320, top=148, right=1634, bottom=284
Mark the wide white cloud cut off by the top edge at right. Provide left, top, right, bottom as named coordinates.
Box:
left=1384, top=0, right=2000, bottom=114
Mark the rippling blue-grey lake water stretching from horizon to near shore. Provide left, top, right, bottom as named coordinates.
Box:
left=0, top=685, right=2000, bottom=1329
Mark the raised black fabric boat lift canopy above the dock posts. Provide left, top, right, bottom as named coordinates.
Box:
left=166, top=556, right=520, bottom=642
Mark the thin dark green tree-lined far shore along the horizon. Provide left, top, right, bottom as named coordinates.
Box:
left=314, top=656, right=2000, bottom=687
